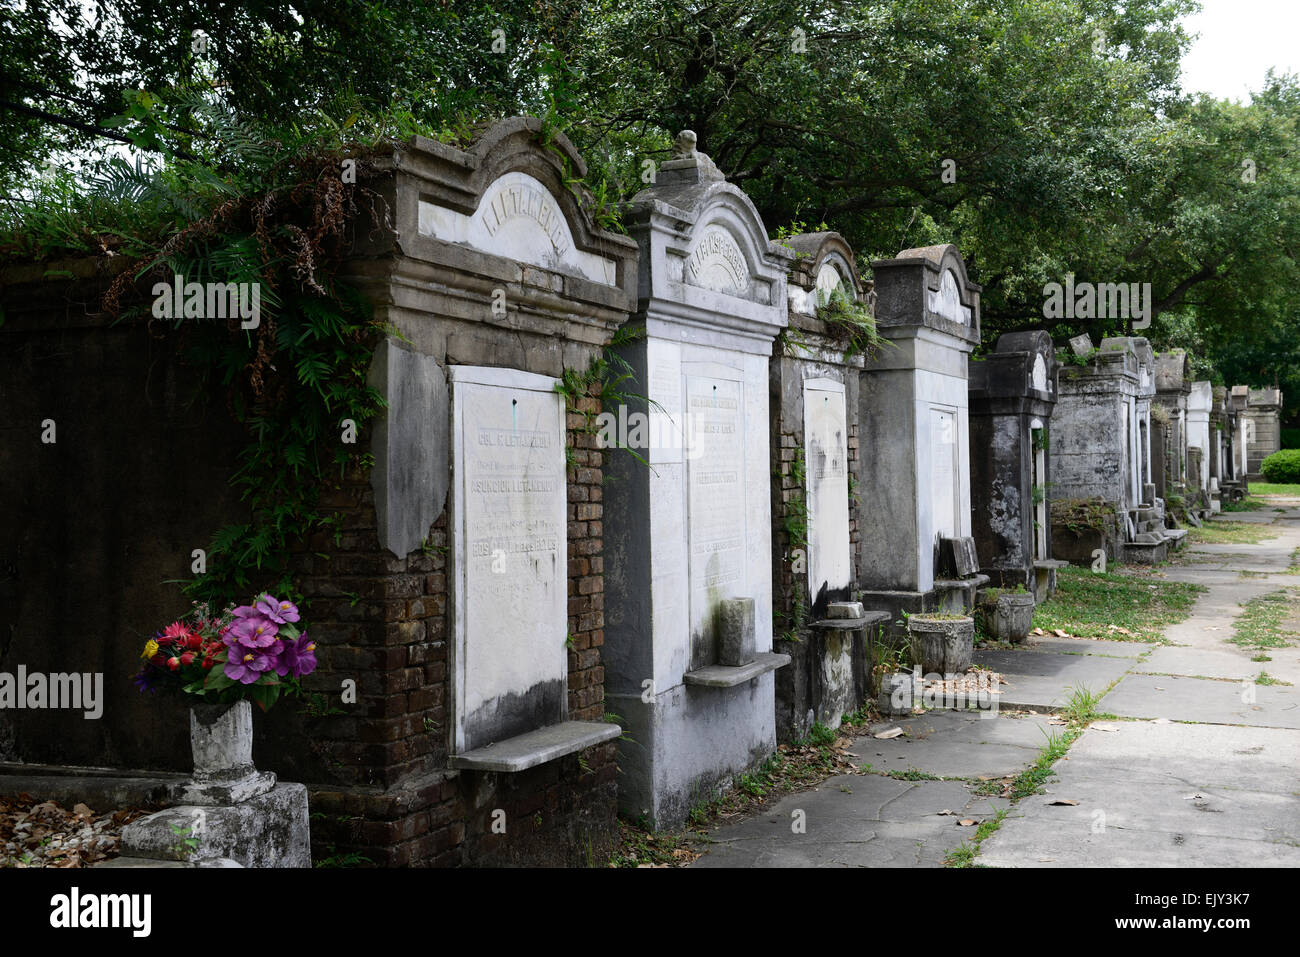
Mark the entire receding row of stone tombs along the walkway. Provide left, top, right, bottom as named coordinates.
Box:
left=0, top=118, right=1279, bottom=863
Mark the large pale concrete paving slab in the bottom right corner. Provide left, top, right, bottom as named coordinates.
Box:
left=979, top=722, right=1300, bottom=867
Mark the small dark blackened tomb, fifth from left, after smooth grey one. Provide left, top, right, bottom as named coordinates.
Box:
left=970, top=330, right=1061, bottom=599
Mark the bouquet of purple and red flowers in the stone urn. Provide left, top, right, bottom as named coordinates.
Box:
left=135, top=594, right=316, bottom=711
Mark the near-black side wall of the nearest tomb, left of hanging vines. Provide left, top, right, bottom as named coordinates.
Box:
left=0, top=270, right=243, bottom=770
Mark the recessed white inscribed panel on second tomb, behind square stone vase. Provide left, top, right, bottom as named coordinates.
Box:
left=684, top=373, right=746, bottom=668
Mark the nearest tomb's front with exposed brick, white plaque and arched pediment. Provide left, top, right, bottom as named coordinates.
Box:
left=327, top=117, right=636, bottom=863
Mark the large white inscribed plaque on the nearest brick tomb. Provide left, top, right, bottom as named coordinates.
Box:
left=450, top=365, right=568, bottom=753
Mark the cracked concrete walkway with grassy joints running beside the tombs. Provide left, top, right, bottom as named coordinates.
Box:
left=694, top=503, right=1300, bottom=867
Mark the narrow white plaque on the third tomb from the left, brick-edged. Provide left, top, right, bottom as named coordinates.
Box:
left=803, top=378, right=853, bottom=602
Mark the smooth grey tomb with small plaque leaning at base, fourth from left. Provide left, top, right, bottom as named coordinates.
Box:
left=858, top=244, right=988, bottom=620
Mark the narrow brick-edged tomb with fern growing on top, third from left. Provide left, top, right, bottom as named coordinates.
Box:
left=770, top=233, right=888, bottom=741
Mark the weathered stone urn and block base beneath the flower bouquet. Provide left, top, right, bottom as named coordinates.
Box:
left=122, top=701, right=312, bottom=867
